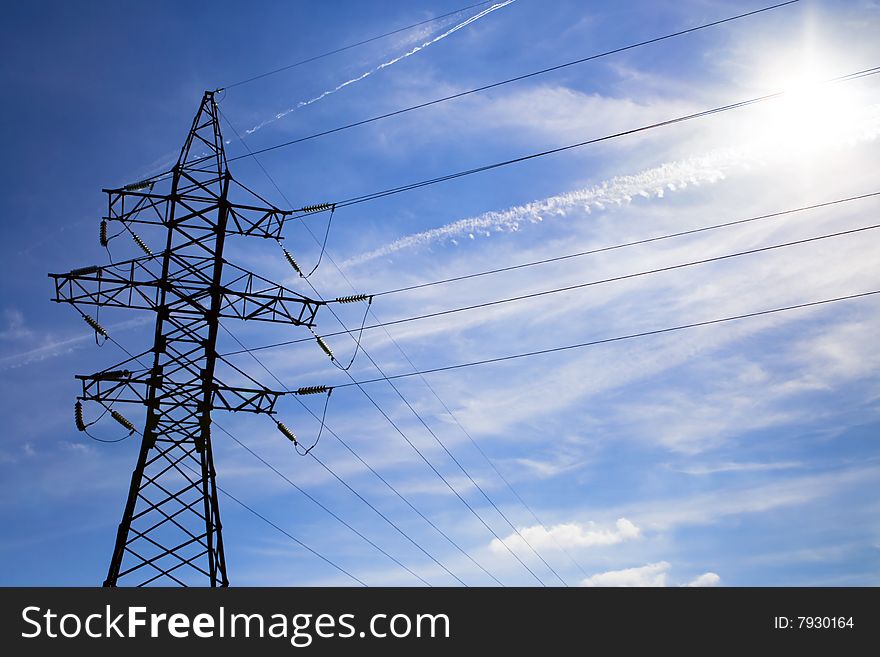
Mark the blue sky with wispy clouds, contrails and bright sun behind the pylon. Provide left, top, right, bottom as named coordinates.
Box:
left=0, top=0, right=880, bottom=586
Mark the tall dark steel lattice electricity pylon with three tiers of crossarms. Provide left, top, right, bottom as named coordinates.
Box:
left=49, top=92, right=334, bottom=586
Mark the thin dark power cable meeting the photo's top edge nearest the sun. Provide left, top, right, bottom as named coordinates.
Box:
left=222, top=0, right=799, bottom=161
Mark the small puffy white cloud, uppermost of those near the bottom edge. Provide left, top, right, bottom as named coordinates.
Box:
left=489, top=518, right=641, bottom=554
